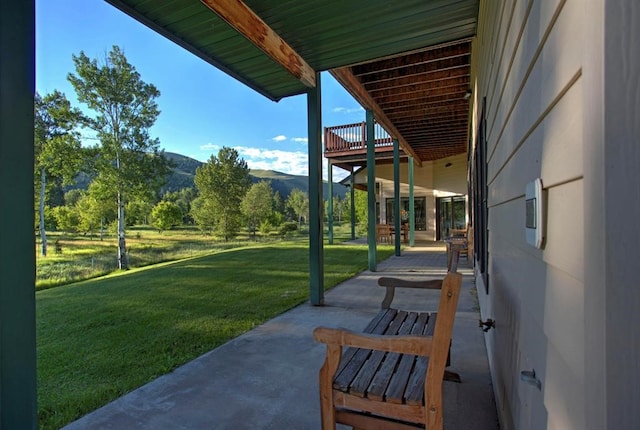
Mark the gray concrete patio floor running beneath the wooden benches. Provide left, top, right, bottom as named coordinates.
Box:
left=65, top=243, right=499, bottom=430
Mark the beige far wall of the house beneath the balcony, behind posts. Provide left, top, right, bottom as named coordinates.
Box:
left=355, top=154, right=468, bottom=240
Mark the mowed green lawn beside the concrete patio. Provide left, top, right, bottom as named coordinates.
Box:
left=36, top=241, right=393, bottom=429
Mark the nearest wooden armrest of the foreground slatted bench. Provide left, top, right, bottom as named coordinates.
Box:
left=313, top=327, right=433, bottom=357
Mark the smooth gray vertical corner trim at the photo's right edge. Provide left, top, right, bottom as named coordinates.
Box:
left=600, top=0, right=640, bottom=429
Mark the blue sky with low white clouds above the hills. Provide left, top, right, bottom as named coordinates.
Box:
left=36, top=0, right=365, bottom=180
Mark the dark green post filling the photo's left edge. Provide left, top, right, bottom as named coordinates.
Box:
left=0, top=0, right=37, bottom=429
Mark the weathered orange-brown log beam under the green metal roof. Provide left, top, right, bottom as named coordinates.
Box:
left=201, top=0, right=316, bottom=88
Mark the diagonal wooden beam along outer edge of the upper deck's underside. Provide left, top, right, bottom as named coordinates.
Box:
left=329, top=67, right=422, bottom=166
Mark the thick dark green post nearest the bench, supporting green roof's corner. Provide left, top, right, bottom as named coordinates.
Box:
left=307, top=73, right=324, bottom=306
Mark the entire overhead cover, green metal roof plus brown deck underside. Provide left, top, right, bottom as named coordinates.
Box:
left=106, top=0, right=479, bottom=162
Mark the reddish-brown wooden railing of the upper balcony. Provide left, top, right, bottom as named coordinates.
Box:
left=324, top=122, right=393, bottom=158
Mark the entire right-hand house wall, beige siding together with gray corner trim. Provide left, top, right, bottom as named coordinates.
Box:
left=472, top=0, right=640, bottom=429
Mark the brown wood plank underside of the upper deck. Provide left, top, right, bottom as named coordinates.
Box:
left=334, top=39, right=471, bottom=161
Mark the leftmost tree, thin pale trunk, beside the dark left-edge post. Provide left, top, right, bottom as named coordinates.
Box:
left=34, top=91, right=81, bottom=256
